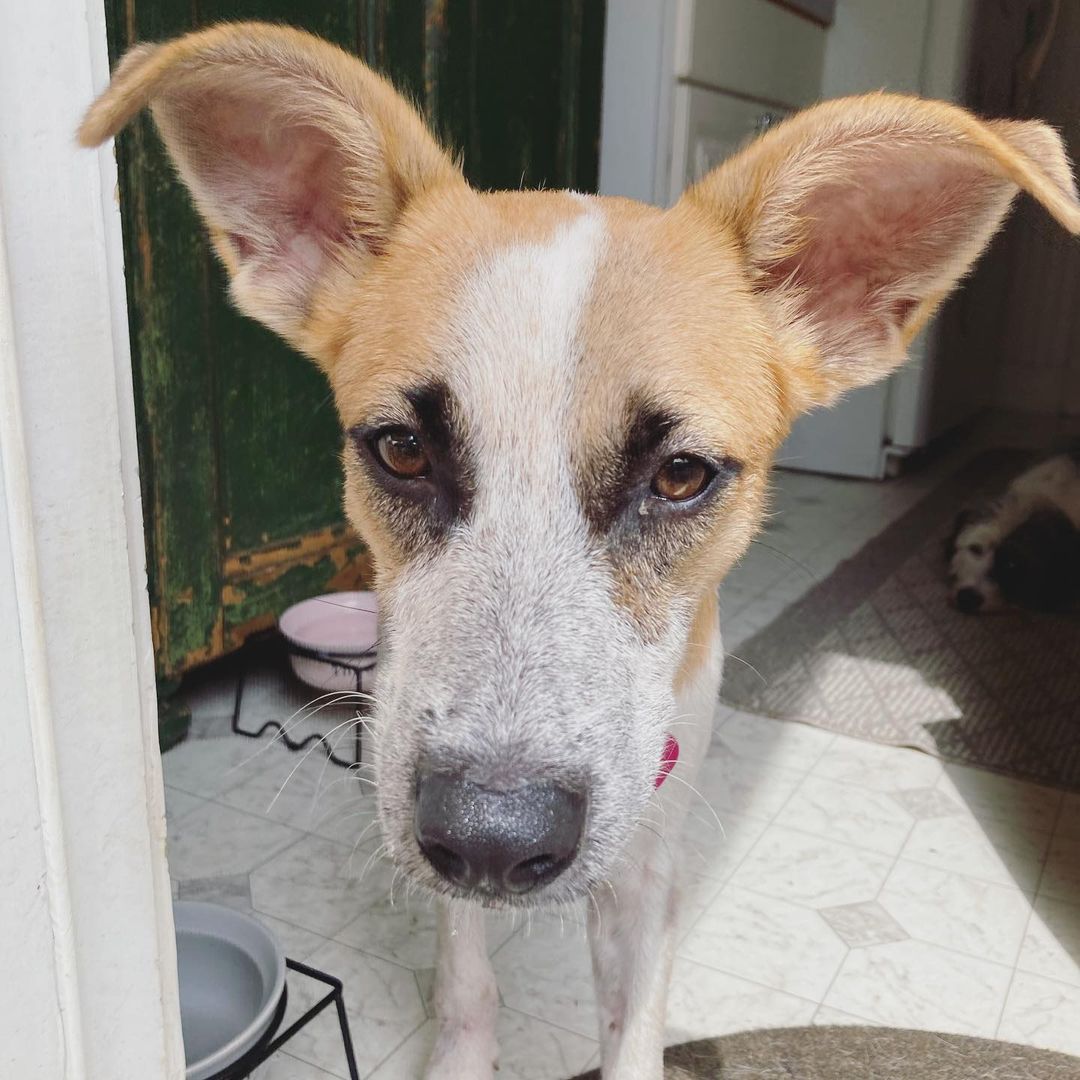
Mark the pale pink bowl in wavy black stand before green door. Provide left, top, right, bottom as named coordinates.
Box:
left=278, top=592, right=379, bottom=691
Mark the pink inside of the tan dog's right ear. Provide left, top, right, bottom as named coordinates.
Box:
left=768, top=146, right=1001, bottom=359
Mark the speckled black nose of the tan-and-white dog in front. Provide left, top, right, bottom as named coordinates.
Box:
left=415, top=772, right=585, bottom=895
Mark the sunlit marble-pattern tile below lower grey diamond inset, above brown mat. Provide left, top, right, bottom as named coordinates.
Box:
left=824, top=941, right=1011, bottom=1037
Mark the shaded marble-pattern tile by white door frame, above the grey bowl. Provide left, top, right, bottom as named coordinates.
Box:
left=167, top=802, right=303, bottom=881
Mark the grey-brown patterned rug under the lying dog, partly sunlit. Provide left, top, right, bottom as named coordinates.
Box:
left=720, top=450, right=1080, bottom=789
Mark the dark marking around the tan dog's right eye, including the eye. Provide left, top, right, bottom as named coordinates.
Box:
left=581, top=404, right=743, bottom=536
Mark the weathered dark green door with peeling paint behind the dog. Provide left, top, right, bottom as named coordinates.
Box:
left=107, top=0, right=604, bottom=677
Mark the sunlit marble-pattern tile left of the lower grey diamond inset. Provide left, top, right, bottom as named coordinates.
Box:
left=678, top=885, right=848, bottom=1001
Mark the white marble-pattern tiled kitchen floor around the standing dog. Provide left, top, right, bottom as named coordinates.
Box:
left=164, top=419, right=1080, bottom=1080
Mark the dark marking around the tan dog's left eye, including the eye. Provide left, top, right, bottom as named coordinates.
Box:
left=347, top=382, right=475, bottom=535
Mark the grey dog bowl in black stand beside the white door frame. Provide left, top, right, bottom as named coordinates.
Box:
left=173, top=900, right=285, bottom=1080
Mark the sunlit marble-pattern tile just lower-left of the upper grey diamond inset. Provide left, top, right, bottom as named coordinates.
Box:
left=775, top=777, right=914, bottom=855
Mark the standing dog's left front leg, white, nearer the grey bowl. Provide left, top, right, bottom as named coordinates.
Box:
left=427, top=903, right=499, bottom=1080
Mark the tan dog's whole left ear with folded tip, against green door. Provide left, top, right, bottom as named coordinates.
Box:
left=79, top=23, right=464, bottom=359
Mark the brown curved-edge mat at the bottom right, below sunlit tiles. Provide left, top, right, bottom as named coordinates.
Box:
left=578, top=1027, right=1080, bottom=1080
